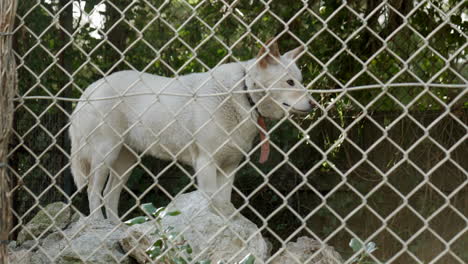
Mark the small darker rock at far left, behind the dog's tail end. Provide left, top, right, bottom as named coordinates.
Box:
left=17, top=202, right=79, bottom=245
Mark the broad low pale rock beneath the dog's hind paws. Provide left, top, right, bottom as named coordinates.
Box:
left=9, top=218, right=135, bottom=264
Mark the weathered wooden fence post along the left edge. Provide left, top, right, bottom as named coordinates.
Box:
left=0, top=0, right=17, bottom=263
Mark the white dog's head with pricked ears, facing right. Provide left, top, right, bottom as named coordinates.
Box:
left=246, top=41, right=313, bottom=119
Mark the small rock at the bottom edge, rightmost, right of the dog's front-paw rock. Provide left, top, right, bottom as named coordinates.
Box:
left=271, top=237, right=343, bottom=264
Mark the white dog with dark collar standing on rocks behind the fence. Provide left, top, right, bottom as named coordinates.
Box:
left=70, top=39, right=312, bottom=221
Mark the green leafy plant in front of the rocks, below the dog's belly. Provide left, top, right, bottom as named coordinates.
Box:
left=125, top=203, right=255, bottom=264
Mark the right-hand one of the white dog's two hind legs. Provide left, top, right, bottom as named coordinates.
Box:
left=103, top=147, right=138, bottom=224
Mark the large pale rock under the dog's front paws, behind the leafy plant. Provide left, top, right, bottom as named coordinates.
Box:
left=120, top=191, right=268, bottom=263
